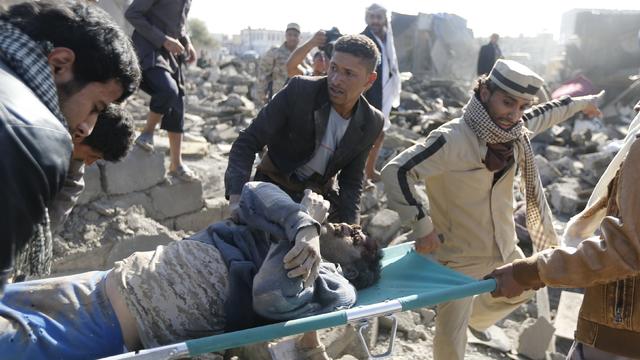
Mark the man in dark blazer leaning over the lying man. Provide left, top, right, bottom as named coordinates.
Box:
left=225, top=35, right=384, bottom=224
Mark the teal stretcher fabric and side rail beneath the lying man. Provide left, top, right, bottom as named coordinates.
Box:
left=181, top=243, right=496, bottom=356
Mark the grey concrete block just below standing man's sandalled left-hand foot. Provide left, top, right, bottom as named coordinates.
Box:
left=102, top=146, right=164, bottom=194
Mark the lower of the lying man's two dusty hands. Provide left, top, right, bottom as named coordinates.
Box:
left=282, top=226, right=320, bottom=287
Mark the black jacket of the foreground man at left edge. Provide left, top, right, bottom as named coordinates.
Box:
left=0, top=61, right=72, bottom=288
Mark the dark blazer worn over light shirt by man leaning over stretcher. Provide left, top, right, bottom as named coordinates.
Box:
left=225, top=77, right=384, bottom=223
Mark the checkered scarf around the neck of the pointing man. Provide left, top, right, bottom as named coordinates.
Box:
left=462, top=96, right=558, bottom=251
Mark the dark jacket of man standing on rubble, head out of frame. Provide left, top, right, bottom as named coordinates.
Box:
left=125, top=0, right=191, bottom=72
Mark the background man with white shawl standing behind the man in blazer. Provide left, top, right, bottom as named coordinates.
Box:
left=362, top=4, right=400, bottom=184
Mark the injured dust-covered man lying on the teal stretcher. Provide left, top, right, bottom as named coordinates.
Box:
left=0, top=182, right=382, bottom=359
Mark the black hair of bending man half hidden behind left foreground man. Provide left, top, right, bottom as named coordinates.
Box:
left=82, top=104, right=134, bottom=162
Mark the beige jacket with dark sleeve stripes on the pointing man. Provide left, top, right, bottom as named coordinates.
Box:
left=382, top=98, right=588, bottom=263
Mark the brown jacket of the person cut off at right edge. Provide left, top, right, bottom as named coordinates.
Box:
left=513, top=136, right=640, bottom=358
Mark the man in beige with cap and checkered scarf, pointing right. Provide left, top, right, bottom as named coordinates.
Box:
left=382, top=60, right=602, bottom=360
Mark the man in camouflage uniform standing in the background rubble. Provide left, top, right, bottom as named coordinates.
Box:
left=257, top=23, right=300, bottom=103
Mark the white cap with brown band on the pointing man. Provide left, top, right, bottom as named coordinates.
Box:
left=489, top=59, right=544, bottom=100
